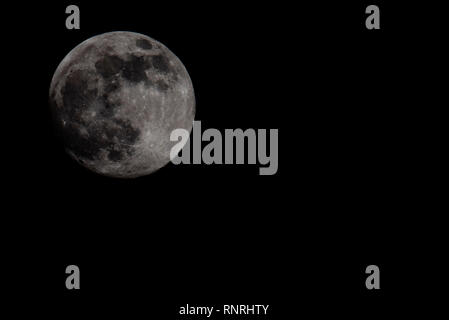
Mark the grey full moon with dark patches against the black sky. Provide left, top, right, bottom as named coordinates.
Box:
left=50, top=32, right=195, bottom=178
